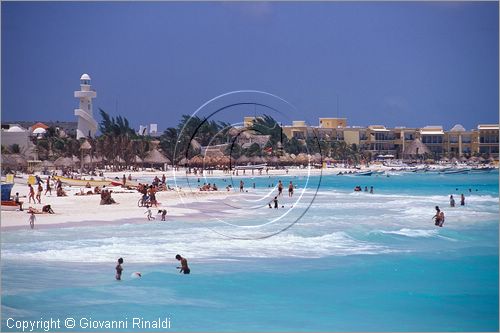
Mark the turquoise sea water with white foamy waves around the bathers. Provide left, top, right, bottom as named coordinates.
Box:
left=2, top=173, right=499, bottom=331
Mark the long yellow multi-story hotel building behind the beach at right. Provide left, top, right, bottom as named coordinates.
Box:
left=244, top=117, right=499, bottom=159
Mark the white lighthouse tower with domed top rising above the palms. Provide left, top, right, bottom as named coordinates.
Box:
left=75, top=74, right=97, bottom=139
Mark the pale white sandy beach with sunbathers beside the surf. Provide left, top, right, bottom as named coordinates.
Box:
left=1, top=164, right=492, bottom=229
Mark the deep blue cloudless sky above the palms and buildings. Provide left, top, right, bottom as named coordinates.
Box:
left=1, top=2, right=499, bottom=130
